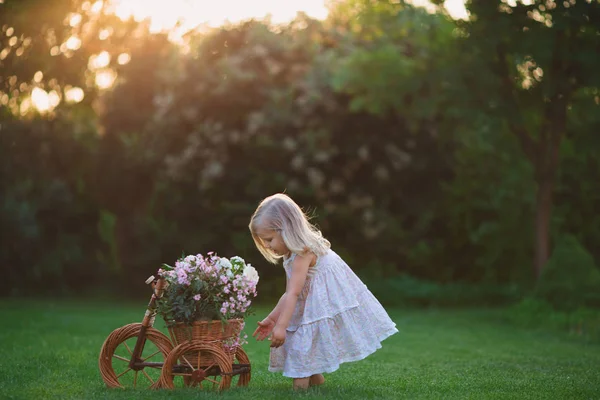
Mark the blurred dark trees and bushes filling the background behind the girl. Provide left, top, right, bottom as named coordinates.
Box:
left=0, top=0, right=600, bottom=314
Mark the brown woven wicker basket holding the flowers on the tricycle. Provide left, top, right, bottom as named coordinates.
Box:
left=169, top=319, right=244, bottom=364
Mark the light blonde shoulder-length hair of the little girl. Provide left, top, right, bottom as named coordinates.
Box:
left=248, top=193, right=331, bottom=264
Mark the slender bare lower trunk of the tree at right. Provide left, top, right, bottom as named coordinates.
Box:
left=533, top=177, right=554, bottom=279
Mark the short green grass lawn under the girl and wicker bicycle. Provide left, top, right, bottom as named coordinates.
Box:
left=0, top=300, right=600, bottom=400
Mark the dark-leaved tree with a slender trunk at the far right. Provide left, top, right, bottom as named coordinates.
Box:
left=458, top=0, right=600, bottom=277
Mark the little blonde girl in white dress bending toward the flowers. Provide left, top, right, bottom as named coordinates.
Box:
left=249, top=194, right=398, bottom=389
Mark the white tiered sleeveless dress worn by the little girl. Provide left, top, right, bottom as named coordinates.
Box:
left=269, top=250, right=398, bottom=378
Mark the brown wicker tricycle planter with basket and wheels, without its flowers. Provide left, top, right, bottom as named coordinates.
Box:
left=98, top=276, right=251, bottom=391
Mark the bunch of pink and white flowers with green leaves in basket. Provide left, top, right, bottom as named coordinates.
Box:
left=157, top=252, right=258, bottom=325
